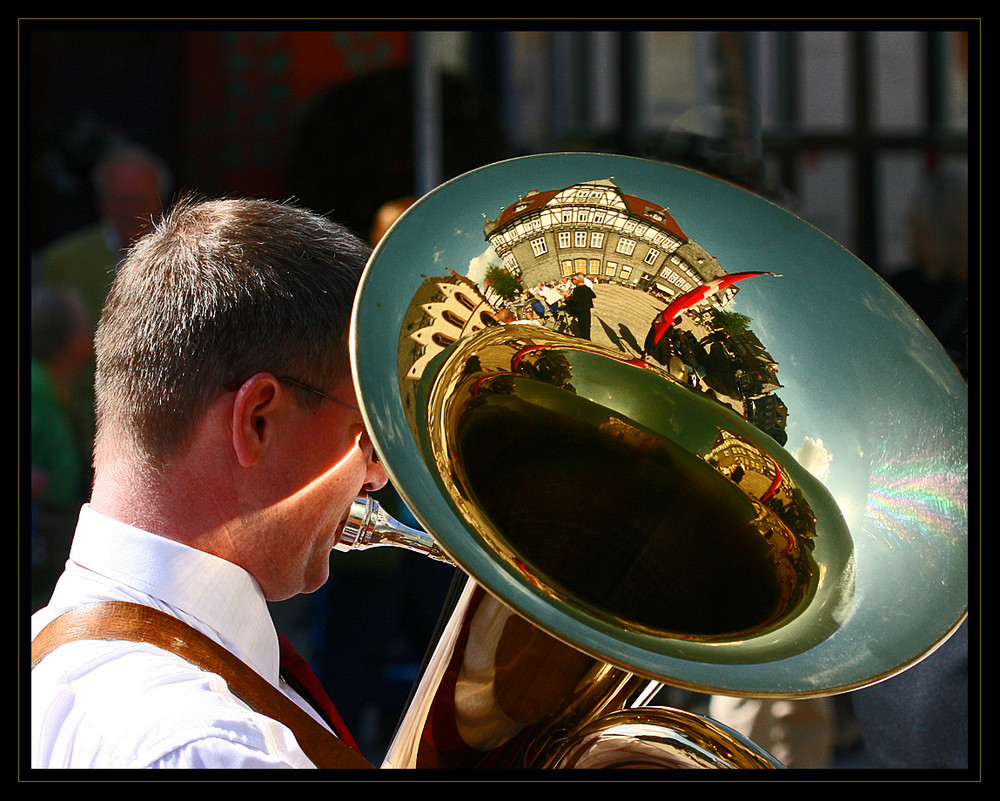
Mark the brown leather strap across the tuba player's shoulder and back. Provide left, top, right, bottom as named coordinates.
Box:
left=31, top=601, right=373, bottom=769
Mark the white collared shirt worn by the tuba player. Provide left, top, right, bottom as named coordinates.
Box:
left=31, top=506, right=328, bottom=768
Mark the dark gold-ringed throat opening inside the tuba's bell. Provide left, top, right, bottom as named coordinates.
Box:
left=428, top=327, right=836, bottom=641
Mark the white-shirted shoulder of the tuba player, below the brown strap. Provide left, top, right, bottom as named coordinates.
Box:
left=31, top=641, right=308, bottom=767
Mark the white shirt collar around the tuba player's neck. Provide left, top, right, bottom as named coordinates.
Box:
left=70, top=504, right=279, bottom=684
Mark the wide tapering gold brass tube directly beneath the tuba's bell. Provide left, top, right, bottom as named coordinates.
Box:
left=385, top=583, right=645, bottom=768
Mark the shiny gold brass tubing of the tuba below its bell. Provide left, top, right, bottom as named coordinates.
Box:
left=383, top=568, right=781, bottom=769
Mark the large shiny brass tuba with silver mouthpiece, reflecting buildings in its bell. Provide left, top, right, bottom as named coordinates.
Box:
left=341, top=153, right=968, bottom=767
